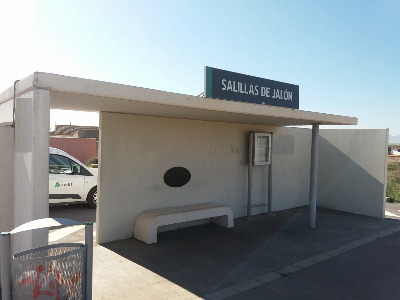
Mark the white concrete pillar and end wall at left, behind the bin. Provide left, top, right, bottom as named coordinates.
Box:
left=0, top=90, right=50, bottom=286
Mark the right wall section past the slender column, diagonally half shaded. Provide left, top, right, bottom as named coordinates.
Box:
left=317, top=129, right=388, bottom=218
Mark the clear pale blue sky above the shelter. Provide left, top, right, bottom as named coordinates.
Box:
left=0, top=0, right=400, bottom=135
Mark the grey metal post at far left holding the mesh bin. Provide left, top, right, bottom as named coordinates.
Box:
left=1, top=232, right=12, bottom=300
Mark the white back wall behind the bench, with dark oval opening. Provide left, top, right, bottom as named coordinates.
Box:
left=97, top=113, right=311, bottom=243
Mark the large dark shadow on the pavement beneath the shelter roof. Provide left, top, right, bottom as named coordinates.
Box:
left=102, top=207, right=400, bottom=296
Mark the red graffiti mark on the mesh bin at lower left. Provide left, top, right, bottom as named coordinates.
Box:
left=18, top=265, right=81, bottom=300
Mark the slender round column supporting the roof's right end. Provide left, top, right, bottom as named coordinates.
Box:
left=309, top=124, right=319, bottom=228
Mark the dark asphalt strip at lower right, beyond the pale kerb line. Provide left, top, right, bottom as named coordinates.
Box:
left=222, top=233, right=400, bottom=300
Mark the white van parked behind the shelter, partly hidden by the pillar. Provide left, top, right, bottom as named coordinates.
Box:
left=49, top=147, right=97, bottom=208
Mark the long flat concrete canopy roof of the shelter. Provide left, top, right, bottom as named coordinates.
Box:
left=0, top=72, right=357, bottom=126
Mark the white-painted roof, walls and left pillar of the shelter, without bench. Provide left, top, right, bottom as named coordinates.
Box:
left=0, top=73, right=387, bottom=248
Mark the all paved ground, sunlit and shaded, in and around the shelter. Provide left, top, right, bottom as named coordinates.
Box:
left=12, top=203, right=394, bottom=300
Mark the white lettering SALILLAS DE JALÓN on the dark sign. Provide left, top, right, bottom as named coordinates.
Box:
left=221, top=78, right=293, bottom=101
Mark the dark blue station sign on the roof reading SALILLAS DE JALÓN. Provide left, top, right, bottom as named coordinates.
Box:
left=204, top=67, right=299, bottom=109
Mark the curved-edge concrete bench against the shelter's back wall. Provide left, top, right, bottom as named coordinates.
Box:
left=133, top=203, right=233, bottom=244
